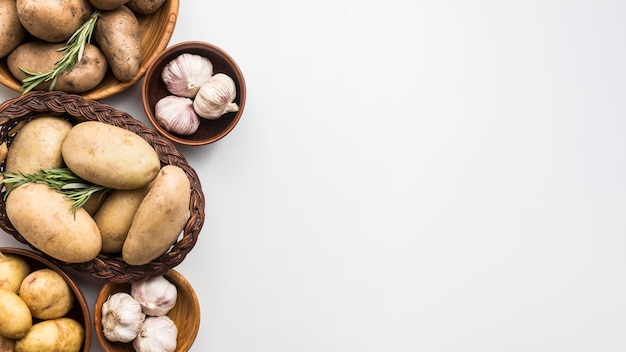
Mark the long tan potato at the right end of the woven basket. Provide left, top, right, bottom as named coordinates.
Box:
left=122, top=165, right=191, bottom=265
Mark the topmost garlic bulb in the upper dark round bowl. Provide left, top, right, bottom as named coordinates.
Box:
left=161, top=53, right=213, bottom=98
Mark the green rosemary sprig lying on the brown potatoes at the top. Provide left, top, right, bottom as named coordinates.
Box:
left=20, top=10, right=100, bottom=94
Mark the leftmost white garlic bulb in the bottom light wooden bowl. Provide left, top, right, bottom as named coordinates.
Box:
left=102, top=292, right=146, bottom=342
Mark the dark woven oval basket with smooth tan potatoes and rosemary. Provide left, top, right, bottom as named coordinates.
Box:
left=0, top=91, right=204, bottom=282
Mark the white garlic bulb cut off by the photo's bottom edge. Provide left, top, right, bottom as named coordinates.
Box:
left=133, top=315, right=178, bottom=352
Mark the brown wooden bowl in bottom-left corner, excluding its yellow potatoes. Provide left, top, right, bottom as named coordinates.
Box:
left=0, top=247, right=91, bottom=352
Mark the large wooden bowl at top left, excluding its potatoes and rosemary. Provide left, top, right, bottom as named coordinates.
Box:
left=0, top=0, right=179, bottom=100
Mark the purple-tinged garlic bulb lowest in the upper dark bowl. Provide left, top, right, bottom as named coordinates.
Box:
left=154, top=95, right=200, bottom=135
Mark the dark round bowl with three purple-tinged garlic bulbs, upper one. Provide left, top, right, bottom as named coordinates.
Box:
left=142, top=41, right=246, bottom=146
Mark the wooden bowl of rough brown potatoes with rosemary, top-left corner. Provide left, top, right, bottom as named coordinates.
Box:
left=0, top=0, right=179, bottom=100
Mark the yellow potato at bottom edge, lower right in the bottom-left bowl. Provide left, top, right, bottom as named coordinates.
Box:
left=15, top=318, right=85, bottom=352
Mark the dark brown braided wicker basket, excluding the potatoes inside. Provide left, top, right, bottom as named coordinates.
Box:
left=0, top=91, right=204, bottom=283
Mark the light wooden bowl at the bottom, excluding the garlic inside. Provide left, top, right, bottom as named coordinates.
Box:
left=93, top=269, right=200, bottom=352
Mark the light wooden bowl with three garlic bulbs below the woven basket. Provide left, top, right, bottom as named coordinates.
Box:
left=94, top=269, right=200, bottom=352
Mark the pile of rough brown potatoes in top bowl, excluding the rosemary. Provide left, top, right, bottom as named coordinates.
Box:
left=0, top=0, right=165, bottom=93
